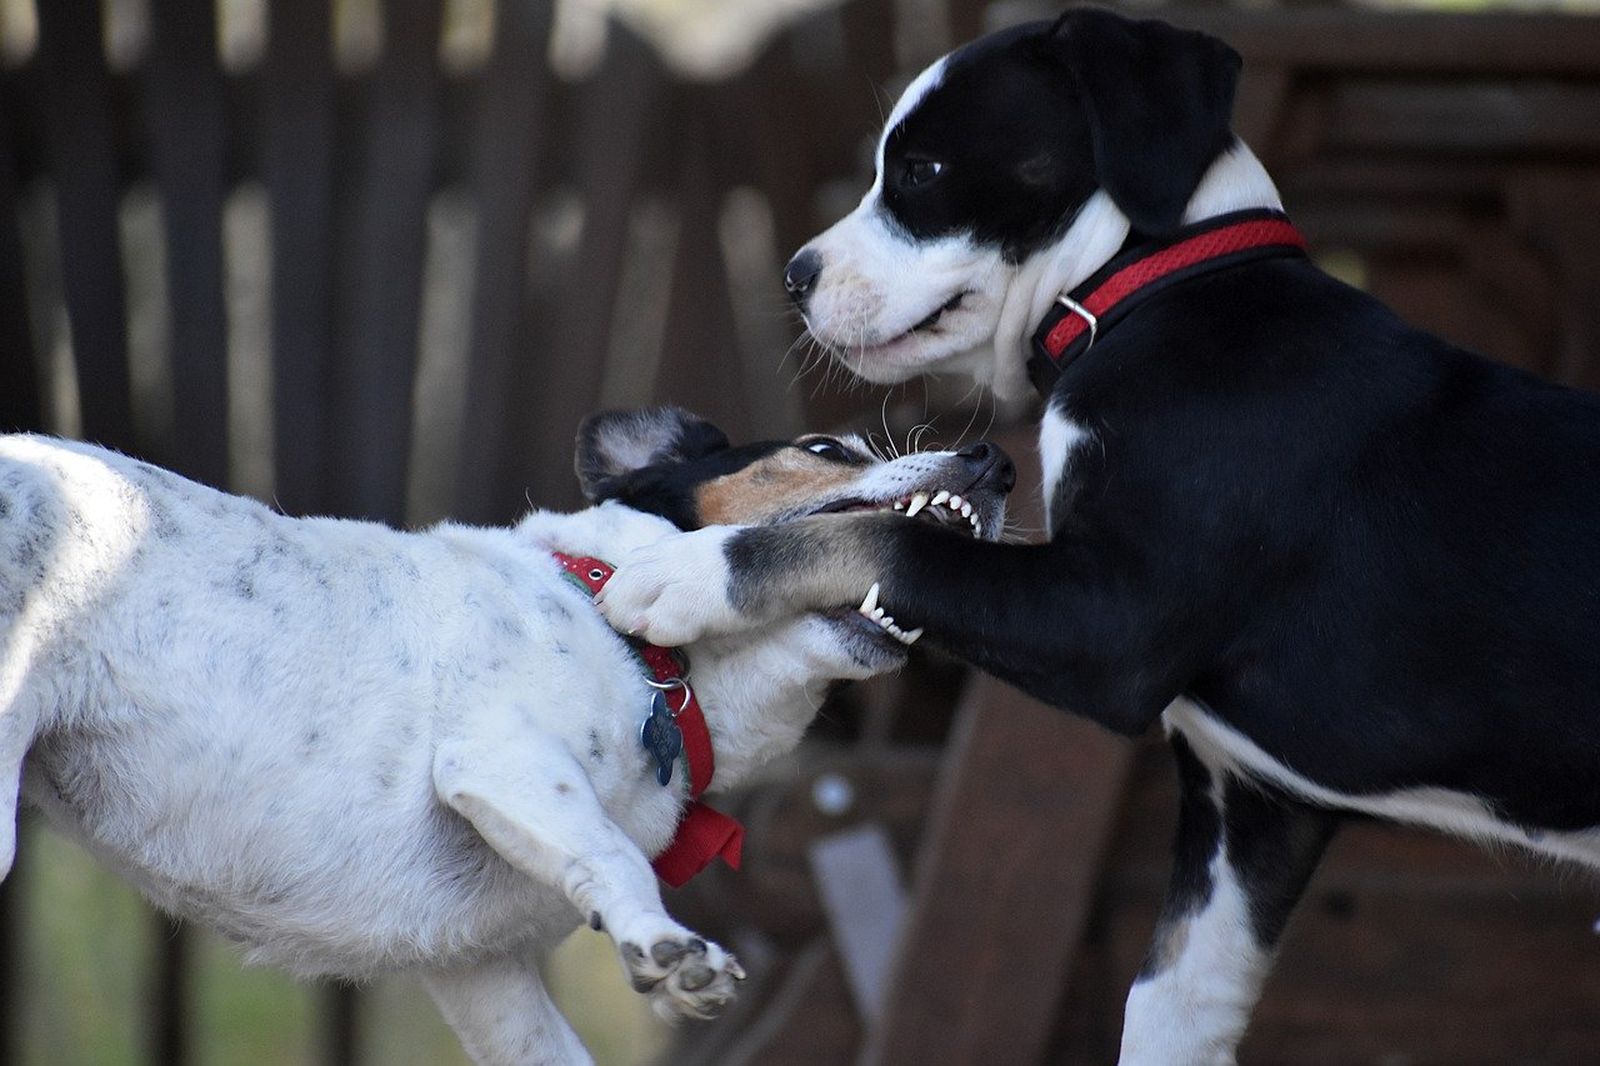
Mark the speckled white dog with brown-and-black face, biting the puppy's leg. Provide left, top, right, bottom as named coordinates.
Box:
left=0, top=408, right=1005, bottom=1063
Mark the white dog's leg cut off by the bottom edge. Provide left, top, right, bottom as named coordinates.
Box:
left=422, top=957, right=592, bottom=1066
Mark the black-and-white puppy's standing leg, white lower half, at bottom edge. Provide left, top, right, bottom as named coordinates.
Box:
left=1120, top=736, right=1339, bottom=1066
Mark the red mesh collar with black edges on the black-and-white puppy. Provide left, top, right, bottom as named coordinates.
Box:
left=1027, top=210, right=1306, bottom=397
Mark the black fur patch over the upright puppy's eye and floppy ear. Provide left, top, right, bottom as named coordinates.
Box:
left=883, top=8, right=1238, bottom=262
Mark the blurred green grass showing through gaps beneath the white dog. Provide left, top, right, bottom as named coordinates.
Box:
left=5, top=818, right=669, bottom=1066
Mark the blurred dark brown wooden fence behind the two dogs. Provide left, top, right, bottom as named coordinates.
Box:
left=0, top=0, right=1600, bottom=1063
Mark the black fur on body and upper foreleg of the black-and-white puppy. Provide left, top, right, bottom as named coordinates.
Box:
left=752, top=249, right=1600, bottom=829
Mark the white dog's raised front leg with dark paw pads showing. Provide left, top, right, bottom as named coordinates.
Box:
left=434, top=731, right=744, bottom=1020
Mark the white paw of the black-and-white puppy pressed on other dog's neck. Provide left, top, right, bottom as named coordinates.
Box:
left=595, top=527, right=747, bottom=647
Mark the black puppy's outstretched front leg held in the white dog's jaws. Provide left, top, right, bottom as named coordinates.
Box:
left=597, top=515, right=1203, bottom=733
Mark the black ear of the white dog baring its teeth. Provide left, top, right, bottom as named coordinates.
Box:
left=573, top=407, right=728, bottom=503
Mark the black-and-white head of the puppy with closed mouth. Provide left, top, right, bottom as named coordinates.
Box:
left=784, top=10, right=1277, bottom=397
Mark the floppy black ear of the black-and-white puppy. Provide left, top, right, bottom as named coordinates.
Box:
left=1051, top=8, right=1242, bottom=237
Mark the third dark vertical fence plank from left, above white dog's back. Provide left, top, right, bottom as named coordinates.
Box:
left=261, top=0, right=334, bottom=514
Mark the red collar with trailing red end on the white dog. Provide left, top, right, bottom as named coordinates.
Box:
left=550, top=552, right=744, bottom=888
